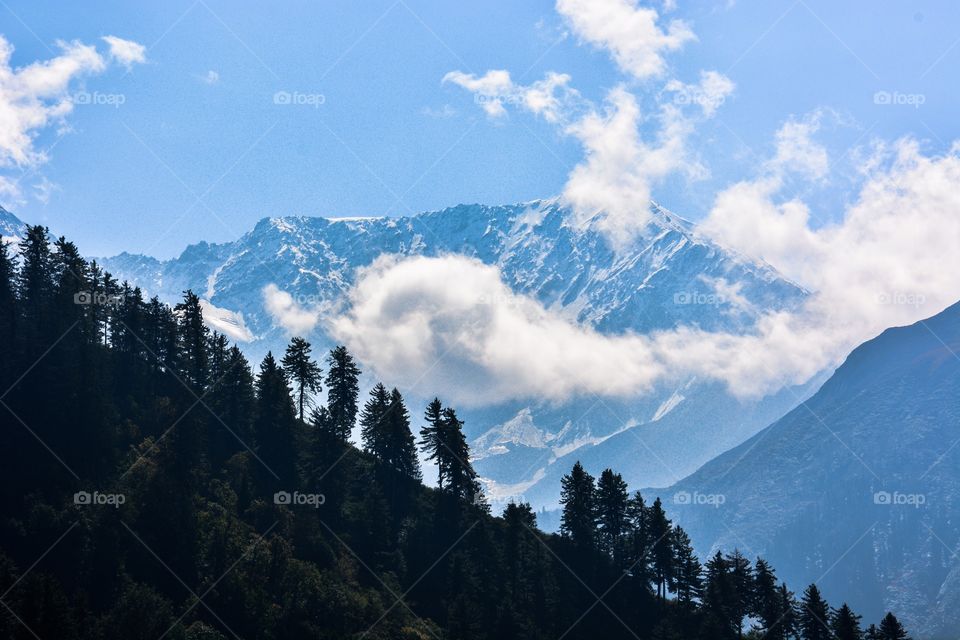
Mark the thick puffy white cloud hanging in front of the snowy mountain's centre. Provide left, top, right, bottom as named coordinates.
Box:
left=330, top=256, right=660, bottom=405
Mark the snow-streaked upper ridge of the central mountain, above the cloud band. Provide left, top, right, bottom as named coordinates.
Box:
left=97, top=198, right=806, bottom=360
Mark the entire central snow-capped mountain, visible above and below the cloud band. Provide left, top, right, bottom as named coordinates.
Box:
left=100, top=199, right=807, bottom=507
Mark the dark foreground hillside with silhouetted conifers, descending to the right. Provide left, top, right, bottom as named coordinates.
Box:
left=0, top=227, right=906, bottom=640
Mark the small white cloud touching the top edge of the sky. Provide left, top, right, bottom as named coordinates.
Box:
left=556, top=0, right=696, bottom=80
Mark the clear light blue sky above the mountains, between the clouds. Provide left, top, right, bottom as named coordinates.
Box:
left=0, top=0, right=960, bottom=257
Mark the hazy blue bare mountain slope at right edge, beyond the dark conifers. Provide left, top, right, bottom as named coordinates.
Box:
left=660, top=303, right=960, bottom=638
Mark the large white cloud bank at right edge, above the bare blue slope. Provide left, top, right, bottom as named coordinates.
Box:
left=701, top=135, right=960, bottom=392
